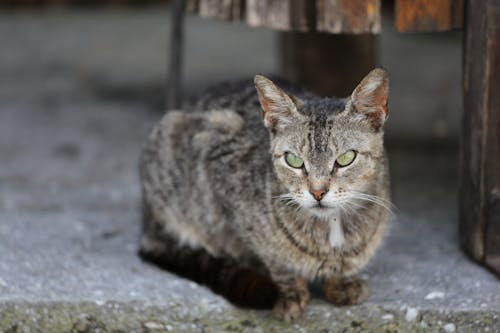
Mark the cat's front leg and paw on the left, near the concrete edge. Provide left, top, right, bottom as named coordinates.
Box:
left=271, top=272, right=310, bottom=322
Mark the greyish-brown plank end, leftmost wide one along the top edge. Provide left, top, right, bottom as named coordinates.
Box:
left=197, top=0, right=244, bottom=21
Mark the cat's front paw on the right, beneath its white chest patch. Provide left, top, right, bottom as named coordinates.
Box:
left=323, top=277, right=369, bottom=305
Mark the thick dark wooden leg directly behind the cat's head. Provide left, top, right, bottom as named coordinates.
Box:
left=280, top=32, right=376, bottom=97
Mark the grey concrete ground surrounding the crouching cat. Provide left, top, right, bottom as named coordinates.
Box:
left=0, top=6, right=500, bottom=332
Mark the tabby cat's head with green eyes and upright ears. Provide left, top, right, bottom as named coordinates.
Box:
left=255, top=69, right=389, bottom=217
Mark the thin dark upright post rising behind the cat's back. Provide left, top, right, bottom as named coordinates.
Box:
left=166, top=0, right=186, bottom=109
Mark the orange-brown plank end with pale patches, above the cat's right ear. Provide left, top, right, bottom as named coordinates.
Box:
left=316, top=0, right=381, bottom=33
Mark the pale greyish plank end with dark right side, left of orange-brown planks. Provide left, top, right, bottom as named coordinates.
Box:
left=246, top=0, right=315, bottom=31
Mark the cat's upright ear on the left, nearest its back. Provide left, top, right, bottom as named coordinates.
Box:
left=254, top=75, right=302, bottom=133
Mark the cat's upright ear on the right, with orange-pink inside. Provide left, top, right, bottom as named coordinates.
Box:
left=351, top=68, right=389, bottom=130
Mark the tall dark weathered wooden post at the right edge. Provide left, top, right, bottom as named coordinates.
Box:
left=460, top=0, right=500, bottom=274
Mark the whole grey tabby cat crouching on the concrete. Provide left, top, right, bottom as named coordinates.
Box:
left=140, top=69, right=389, bottom=321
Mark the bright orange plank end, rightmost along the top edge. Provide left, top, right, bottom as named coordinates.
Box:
left=396, top=0, right=464, bottom=32
